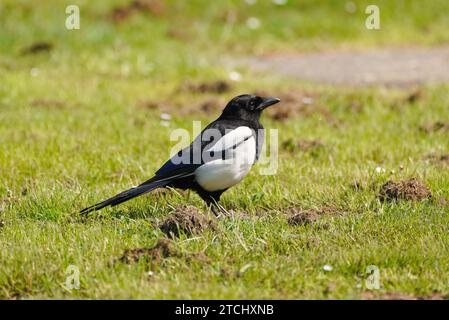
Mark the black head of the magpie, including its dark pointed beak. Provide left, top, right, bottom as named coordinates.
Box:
left=221, top=94, right=281, bottom=121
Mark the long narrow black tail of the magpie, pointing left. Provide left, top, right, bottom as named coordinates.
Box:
left=80, top=179, right=171, bottom=214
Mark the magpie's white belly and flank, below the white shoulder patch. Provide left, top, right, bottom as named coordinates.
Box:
left=195, top=136, right=256, bottom=191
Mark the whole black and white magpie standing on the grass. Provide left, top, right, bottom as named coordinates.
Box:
left=80, top=94, right=280, bottom=215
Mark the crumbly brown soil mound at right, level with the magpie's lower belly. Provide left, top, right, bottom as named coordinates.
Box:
left=379, top=178, right=432, bottom=201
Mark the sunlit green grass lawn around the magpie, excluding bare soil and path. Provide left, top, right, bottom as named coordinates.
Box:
left=0, top=1, right=449, bottom=299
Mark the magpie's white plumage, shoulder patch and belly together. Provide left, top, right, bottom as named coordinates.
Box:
left=195, top=127, right=256, bottom=191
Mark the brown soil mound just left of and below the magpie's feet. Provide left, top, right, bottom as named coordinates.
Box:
left=160, top=207, right=217, bottom=237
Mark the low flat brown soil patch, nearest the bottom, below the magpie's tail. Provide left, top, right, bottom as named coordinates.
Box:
left=118, top=239, right=177, bottom=263
